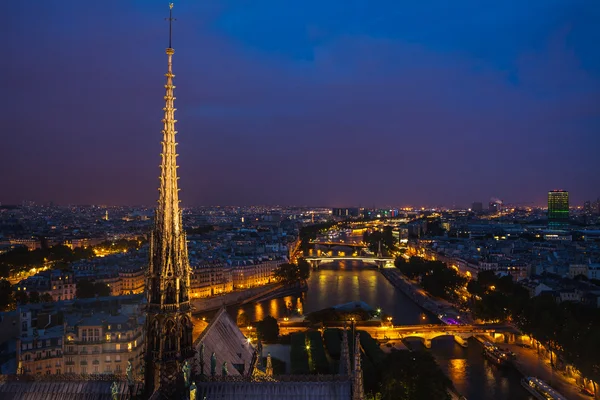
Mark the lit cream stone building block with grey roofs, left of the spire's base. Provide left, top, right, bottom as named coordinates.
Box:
left=17, top=305, right=144, bottom=375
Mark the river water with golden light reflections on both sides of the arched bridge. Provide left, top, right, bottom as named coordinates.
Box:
left=230, top=261, right=533, bottom=400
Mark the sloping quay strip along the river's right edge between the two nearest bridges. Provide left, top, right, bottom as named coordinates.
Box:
left=380, top=268, right=472, bottom=324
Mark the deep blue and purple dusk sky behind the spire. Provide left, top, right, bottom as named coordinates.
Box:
left=0, top=0, right=600, bottom=206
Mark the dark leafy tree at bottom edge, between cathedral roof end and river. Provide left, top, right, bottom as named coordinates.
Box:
left=381, top=351, right=452, bottom=400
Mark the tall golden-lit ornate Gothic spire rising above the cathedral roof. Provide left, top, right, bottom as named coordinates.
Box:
left=145, top=4, right=193, bottom=398
